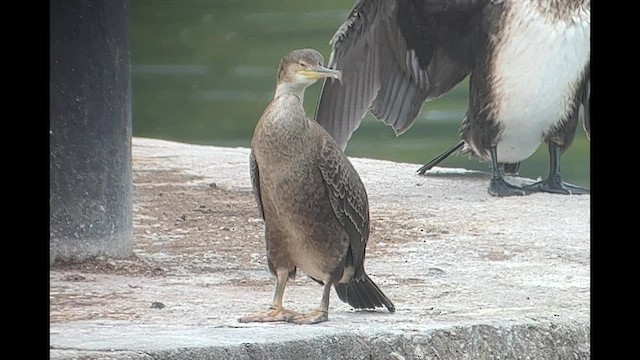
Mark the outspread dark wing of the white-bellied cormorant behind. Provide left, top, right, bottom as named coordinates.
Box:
left=316, top=0, right=488, bottom=150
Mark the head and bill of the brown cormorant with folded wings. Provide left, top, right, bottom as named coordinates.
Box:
left=277, top=49, right=342, bottom=93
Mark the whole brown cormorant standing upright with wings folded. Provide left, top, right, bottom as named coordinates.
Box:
left=239, top=49, right=395, bottom=324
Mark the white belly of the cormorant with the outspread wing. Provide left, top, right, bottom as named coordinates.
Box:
left=493, top=1, right=591, bottom=163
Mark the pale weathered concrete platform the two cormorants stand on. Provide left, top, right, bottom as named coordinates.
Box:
left=50, top=138, right=590, bottom=359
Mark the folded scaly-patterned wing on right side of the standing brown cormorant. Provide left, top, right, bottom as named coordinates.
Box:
left=319, top=139, right=369, bottom=278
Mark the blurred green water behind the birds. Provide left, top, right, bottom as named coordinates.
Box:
left=131, top=0, right=590, bottom=186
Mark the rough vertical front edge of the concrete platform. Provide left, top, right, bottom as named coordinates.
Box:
left=51, top=322, right=589, bottom=360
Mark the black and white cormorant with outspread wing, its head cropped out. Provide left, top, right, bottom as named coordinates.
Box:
left=316, top=0, right=591, bottom=196
